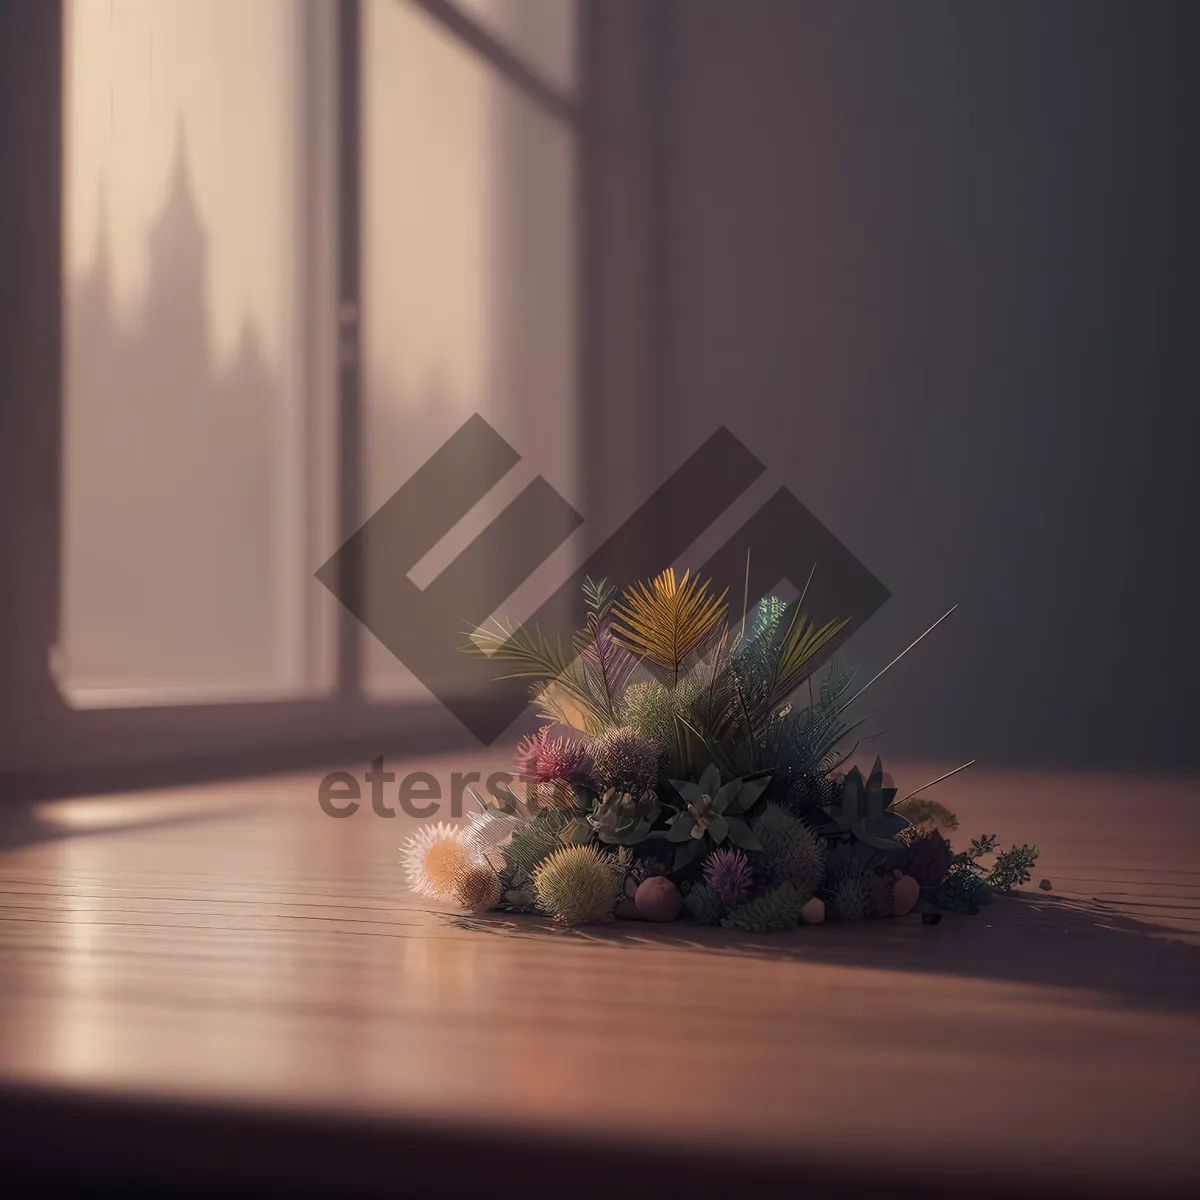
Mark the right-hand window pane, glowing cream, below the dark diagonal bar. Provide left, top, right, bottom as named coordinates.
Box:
left=362, top=0, right=581, bottom=696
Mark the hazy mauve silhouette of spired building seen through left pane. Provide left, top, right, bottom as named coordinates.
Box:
left=64, top=128, right=277, bottom=686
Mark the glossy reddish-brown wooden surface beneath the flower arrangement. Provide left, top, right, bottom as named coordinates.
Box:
left=0, top=758, right=1200, bottom=1195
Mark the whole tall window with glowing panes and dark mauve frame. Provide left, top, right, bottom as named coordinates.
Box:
left=0, top=0, right=656, bottom=782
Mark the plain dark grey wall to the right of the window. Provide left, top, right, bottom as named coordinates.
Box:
left=664, top=0, right=1200, bottom=769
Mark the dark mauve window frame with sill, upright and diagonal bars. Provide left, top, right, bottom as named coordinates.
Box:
left=0, top=0, right=665, bottom=799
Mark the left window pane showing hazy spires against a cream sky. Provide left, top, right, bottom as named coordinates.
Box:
left=56, top=0, right=332, bottom=703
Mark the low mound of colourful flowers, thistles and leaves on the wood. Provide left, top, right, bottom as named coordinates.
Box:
left=402, top=570, right=1037, bottom=934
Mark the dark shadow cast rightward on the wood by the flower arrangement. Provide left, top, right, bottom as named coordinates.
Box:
left=446, top=877, right=1200, bottom=1013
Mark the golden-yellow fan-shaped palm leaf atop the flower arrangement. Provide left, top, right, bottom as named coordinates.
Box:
left=612, top=568, right=728, bottom=672
